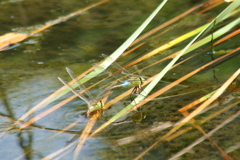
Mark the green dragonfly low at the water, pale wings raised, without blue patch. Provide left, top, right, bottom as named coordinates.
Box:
left=58, top=67, right=115, bottom=118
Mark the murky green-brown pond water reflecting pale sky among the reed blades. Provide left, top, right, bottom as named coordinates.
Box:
left=0, top=0, right=240, bottom=160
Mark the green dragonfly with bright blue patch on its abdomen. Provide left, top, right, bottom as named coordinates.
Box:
left=102, top=54, right=145, bottom=101
